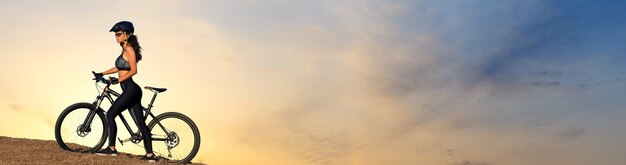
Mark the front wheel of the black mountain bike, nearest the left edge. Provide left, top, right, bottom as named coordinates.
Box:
left=54, top=103, right=107, bottom=152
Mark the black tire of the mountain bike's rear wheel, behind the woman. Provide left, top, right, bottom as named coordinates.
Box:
left=148, top=112, right=200, bottom=163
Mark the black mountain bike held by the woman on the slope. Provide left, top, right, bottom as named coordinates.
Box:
left=54, top=74, right=200, bottom=163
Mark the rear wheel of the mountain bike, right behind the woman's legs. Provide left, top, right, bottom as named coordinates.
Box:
left=148, top=112, right=200, bottom=163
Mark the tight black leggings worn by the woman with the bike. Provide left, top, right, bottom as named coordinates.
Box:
left=106, top=78, right=152, bottom=153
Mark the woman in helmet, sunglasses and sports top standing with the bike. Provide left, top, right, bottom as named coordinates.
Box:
left=96, top=21, right=156, bottom=162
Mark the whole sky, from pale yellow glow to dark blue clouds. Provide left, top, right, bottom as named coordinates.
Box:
left=0, top=0, right=626, bottom=165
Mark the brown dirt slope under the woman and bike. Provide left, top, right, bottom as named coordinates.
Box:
left=0, top=136, right=205, bottom=164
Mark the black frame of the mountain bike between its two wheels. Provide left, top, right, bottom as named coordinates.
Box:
left=81, top=82, right=169, bottom=145
